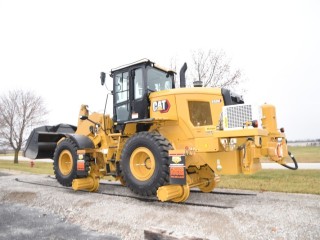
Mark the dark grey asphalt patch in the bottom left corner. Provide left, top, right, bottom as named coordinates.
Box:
left=0, top=203, right=120, bottom=240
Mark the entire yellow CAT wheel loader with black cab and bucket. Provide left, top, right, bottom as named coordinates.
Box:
left=25, top=59, right=298, bottom=202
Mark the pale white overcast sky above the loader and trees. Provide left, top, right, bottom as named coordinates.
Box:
left=0, top=0, right=320, bottom=140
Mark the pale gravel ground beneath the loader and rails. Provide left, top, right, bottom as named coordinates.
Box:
left=0, top=169, right=320, bottom=239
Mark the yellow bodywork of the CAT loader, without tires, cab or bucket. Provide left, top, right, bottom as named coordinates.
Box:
left=73, top=88, right=288, bottom=202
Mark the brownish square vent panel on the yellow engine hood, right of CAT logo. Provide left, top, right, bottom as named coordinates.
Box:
left=188, top=101, right=212, bottom=126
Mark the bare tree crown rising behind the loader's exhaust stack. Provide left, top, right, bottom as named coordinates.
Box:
left=191, top=50, right=241, bottom=88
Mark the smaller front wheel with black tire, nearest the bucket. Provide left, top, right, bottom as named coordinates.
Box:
left=53, top=138, right=78, bottom=187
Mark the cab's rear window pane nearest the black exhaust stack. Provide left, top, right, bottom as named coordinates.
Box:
left=147, top=67, right=173, bottom=91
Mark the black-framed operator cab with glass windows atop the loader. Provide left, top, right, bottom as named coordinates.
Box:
left=110, top=59, right=175, bottom=130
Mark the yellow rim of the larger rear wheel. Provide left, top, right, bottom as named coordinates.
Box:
left=130, top=147, right=156, bottom=181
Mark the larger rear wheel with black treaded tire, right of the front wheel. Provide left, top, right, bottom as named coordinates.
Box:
left=120, top=132, right=172, bottom=196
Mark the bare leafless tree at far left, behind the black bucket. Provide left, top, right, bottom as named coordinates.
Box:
left=0, top=90, right=48, bottom=163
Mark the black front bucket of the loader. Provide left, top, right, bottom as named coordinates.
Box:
left=24, top=124, right=77, bottom=159
